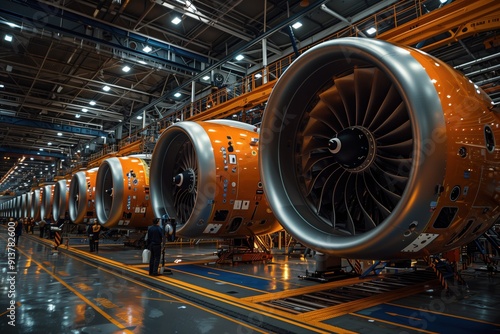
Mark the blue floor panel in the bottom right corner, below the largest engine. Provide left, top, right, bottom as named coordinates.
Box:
left=356, top=304, right=500, bottom=334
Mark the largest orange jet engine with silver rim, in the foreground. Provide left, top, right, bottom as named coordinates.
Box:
left=260, top=38, right=500, bottom=260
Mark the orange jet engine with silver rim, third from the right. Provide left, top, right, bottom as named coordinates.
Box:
left=95, top=155, right=154, bottom=228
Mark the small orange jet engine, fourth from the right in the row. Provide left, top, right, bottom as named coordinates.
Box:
left=68, top=168, right=98, bottom=224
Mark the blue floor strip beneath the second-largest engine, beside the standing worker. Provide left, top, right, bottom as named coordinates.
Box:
left=171, top=264, right=285, bottom=291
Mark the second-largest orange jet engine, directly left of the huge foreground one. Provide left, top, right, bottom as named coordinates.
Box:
left=151, top=120, right=282, bottom=239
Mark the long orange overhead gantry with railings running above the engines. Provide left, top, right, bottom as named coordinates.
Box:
left=61, top=0, right=500, bottom=177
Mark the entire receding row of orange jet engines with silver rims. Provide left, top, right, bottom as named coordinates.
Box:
left=2, top=38, right=500, bottom=259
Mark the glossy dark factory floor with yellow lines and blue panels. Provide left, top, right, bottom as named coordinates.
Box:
left=0, top=226, right=500, bottom=334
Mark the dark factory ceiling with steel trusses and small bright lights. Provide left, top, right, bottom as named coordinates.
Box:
left=0, top=0, right=500, bottom=201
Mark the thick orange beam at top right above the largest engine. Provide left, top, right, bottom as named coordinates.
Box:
left=377, top=0, right=500, bottom=51
